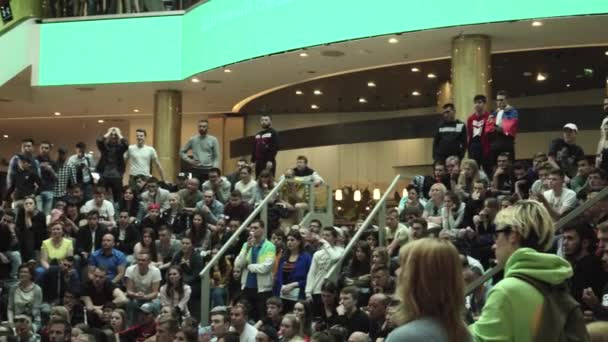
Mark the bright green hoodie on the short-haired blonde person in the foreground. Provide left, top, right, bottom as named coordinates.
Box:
left=469, top=248, right=572, bottom=342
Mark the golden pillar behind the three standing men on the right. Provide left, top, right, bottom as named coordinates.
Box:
left=452, top=35, right=492, bottom=122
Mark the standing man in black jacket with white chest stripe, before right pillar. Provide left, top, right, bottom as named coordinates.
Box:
left=433, top=103, right=467, bottom=161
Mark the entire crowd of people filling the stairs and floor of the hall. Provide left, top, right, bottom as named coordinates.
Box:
left=0, top=95, right=608, bottom=342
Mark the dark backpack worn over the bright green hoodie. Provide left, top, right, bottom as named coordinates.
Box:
left=512, top=274, right=590, bottom=342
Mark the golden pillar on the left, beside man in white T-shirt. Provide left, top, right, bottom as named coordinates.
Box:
left=154, top=90, right=182, bottom=182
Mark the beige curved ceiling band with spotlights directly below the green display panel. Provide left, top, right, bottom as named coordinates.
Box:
left=0, top=16, right=608, bottom=120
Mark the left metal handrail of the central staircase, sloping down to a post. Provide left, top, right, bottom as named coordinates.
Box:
left=198, top=179, right=287, bottom=324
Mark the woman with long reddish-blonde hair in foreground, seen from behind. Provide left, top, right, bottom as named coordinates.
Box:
left=386, top=238, right=470, bottom=342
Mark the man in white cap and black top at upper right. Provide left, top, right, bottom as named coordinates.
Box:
left=549, top=123, right=585, bottom=178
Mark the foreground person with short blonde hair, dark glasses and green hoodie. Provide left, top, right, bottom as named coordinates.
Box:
left=469, top=200, right=587, bottom=341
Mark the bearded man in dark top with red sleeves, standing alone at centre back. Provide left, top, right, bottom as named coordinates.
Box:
left=251, top=115, right=279, bottom=177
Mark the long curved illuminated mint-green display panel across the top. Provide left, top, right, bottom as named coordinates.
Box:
left=38, top=0, right=608, bottom=85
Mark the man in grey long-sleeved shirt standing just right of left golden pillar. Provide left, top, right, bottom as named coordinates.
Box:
left=180, top=119, right=221, bottom=184
